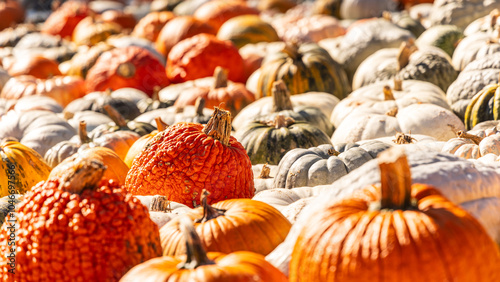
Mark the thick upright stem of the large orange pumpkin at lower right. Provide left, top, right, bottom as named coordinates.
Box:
left=378, top=146, right=415, bottom=210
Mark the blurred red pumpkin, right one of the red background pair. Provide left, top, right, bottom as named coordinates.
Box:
left=166, top=33, right=243, bottom=83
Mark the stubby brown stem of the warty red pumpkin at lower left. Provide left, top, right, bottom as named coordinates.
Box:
left=59, top=159, right=106, bottom=194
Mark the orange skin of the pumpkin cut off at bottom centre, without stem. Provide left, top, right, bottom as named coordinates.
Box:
left=120, top=252, right=288, bottom=282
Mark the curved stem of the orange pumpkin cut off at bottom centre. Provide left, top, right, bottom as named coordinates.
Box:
left=177, top=215, right=215, bottom=269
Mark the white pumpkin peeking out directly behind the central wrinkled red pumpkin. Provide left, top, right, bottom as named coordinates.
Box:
left=135, top=98, right=214, bottom=124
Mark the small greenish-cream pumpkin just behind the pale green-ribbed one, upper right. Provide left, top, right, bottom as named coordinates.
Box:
left=415, top=25, right=464, bottom=57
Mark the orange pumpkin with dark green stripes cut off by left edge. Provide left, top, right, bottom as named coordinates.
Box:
left=0, top=141, right=50, bottom=197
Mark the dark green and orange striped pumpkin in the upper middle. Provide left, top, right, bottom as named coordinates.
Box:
left=255, top=43, right=351, bottom=99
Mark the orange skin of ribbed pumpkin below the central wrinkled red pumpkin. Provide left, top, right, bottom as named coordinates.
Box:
left=160, top=199, right=292, bottom=256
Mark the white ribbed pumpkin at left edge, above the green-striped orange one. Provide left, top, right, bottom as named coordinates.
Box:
left=0, top=110, right=76, bottom=156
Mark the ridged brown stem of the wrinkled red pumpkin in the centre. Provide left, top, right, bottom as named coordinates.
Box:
left=203, top=107, right=231, bottom=146
